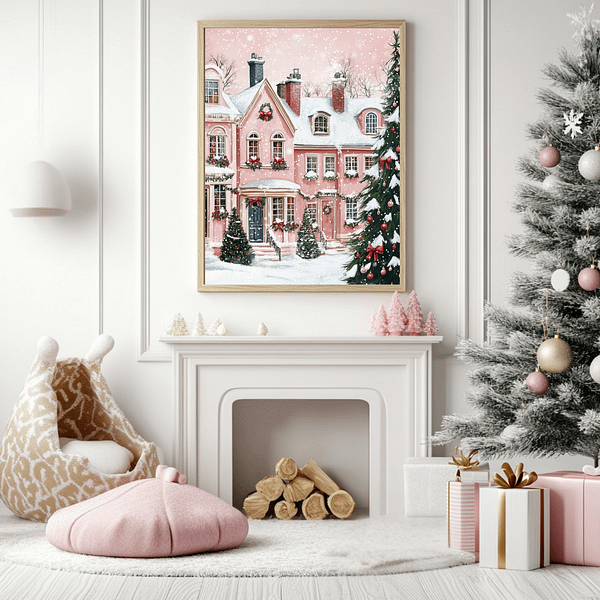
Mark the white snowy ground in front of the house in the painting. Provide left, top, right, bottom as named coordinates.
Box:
left=205, top=252, right=350, bottom=285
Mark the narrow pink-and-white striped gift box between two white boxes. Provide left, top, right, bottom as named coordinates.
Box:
left=447, top=481, right=481, bottom=555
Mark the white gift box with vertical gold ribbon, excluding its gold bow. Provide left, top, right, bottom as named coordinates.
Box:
left=479, top=487, right=550, bottom=571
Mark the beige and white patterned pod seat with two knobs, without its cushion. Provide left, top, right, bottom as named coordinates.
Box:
left=0, top=335, right=159, bottom=522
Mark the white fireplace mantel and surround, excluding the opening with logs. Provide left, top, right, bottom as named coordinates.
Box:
left=160, top=336, right=443, bottom=516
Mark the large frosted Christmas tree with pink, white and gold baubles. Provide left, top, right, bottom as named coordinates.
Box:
left=434, top=9, right=600, bottom=466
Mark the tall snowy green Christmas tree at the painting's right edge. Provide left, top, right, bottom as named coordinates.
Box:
left=345, top=32, right=402, bottom=284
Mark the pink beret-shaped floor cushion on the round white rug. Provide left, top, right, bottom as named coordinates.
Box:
left=46, top=465, right=248, bottom=558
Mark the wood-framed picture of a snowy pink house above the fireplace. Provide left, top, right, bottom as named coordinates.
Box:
left=198, top=21, right=406, bottom=292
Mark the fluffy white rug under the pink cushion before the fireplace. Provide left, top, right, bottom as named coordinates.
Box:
left=0, top=516, right=475, bottom=577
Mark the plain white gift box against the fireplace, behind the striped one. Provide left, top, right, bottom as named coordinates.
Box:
left=404, top=456, right=490, bottom=517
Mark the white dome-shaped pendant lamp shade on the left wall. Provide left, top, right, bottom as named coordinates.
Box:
left=10, top=160, right=72, bottom=217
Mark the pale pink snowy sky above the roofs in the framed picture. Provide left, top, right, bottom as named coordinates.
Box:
left=205, top=27, right=394, bottom=95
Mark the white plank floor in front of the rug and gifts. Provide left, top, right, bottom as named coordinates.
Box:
left=0, top=562, right=600, bottom=600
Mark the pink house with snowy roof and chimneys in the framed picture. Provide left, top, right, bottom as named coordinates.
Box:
left=203, top=53, right=384, bottom=260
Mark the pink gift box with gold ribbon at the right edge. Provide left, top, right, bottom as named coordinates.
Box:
left=535, top=471, right=600, bottom=567
